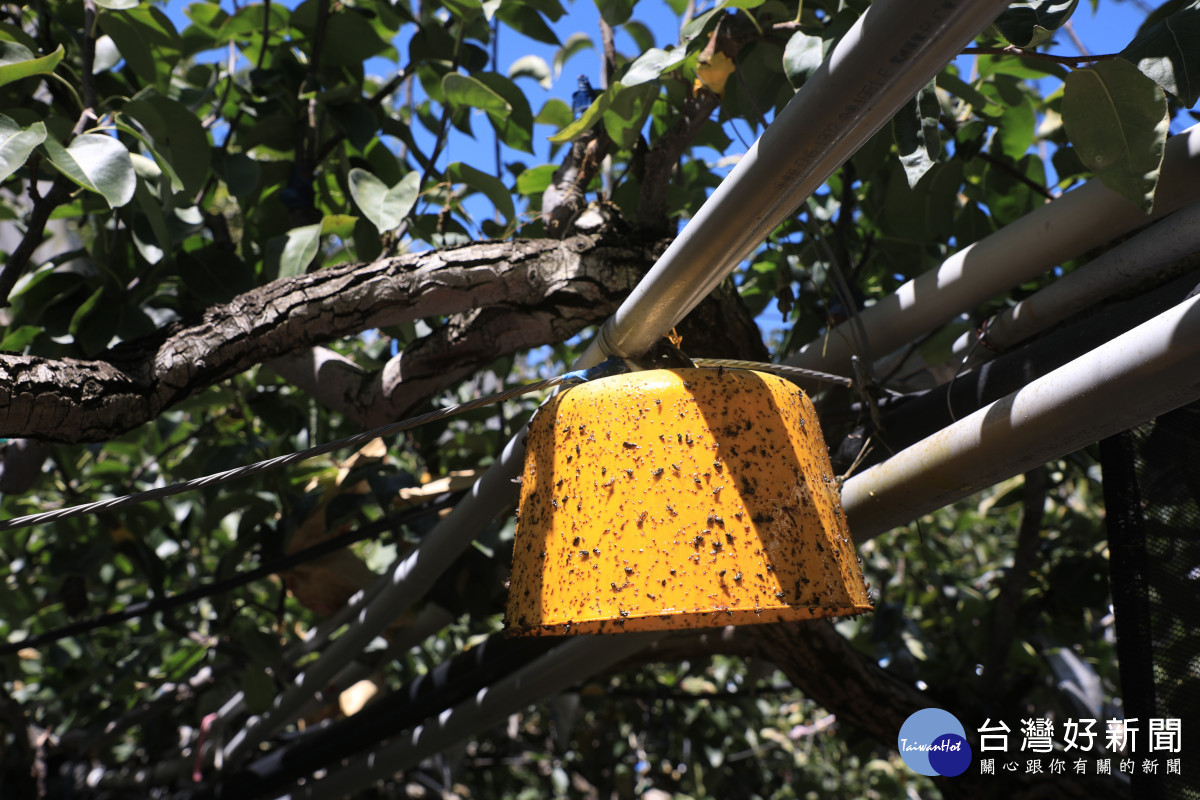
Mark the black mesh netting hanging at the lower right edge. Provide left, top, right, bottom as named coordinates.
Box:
left=1102, top=404, right=1200, bottom=800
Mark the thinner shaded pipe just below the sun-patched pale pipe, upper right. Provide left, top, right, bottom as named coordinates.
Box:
left=952, top=203, right=1200, bottom=368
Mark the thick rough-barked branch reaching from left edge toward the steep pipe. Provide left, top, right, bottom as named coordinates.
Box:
left=0, top=231, right=656, bottom=443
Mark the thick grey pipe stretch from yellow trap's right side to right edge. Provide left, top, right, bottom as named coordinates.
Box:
left=841, top=291, right=1200, bottom=542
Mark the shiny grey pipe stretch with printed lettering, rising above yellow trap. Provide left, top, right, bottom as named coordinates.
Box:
left=584, top=0, right=1007, bottom=363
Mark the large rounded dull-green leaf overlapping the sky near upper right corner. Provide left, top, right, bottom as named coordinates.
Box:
left=1062, top=59, right=1170, bottom=213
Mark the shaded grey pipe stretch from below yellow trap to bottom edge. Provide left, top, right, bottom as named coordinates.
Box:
left=282, top=633, right=661, bottom=800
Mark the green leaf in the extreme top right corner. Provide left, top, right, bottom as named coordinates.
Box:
left=1121, top=2, right=1200, bottom=108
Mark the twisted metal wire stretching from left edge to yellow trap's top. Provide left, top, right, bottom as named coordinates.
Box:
left=0, top=373, right=576, bottom=531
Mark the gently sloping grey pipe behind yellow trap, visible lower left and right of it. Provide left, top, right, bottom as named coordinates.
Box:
left=278, top=296, right=1200, bottom=800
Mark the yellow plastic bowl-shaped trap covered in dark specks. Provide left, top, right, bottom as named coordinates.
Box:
left=506, top=369, right=871, bottom=636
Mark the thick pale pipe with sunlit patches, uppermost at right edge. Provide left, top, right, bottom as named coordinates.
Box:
left=785, top=125, right=1200, bottom=374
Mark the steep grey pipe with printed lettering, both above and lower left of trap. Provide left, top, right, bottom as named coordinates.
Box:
left=223, top=0, right=1007, bottom=762
